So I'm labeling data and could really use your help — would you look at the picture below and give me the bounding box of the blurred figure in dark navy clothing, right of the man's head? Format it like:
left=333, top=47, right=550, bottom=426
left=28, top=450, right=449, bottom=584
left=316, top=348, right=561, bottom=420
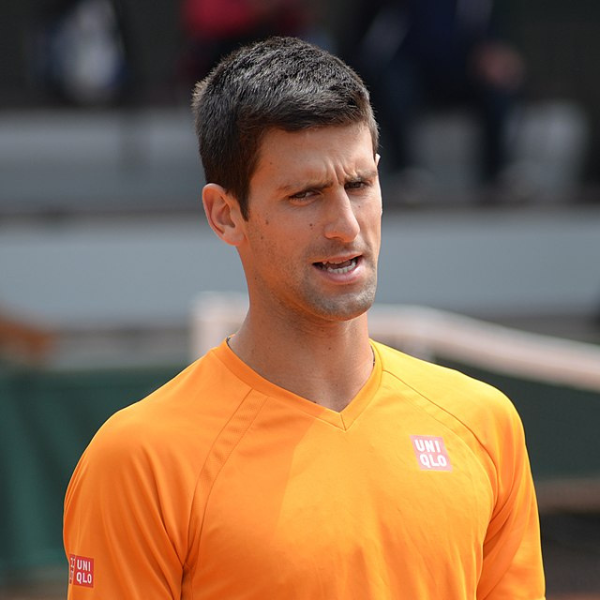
left=348, top=0, right=524, bottom=195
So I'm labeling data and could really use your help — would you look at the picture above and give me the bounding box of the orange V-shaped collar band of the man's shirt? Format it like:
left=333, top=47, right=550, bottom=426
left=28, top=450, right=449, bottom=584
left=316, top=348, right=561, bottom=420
left=212, top=340, right=382, bottom=431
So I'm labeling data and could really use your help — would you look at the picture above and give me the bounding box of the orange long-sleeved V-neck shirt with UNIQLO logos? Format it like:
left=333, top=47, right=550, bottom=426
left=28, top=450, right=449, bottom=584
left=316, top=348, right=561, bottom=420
left=64, top=343, right=544, bottom=600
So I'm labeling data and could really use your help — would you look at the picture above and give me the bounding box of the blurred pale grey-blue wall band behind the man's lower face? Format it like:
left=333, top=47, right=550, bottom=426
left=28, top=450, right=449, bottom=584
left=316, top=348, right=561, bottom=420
left=0, top=208, right=600, bottom=326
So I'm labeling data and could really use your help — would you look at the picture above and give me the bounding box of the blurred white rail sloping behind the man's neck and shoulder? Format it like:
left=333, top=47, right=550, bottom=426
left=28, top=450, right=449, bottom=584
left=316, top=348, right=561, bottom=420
left=192, top=293, right=600, bottom=391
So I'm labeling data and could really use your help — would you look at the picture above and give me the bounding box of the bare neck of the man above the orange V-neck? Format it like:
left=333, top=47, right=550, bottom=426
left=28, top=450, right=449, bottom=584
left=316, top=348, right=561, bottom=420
left=230, top=311, right=373, bottom=411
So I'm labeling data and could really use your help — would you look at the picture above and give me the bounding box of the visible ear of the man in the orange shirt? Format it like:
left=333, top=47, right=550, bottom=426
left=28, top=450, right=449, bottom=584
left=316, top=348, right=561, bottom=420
left=202, top=183, right=244, bottom=246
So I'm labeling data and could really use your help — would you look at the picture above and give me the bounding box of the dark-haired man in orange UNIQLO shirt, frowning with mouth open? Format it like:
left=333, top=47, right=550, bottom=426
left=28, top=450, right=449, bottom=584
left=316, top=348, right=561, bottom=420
left=65, top=38, right=544, bottom=600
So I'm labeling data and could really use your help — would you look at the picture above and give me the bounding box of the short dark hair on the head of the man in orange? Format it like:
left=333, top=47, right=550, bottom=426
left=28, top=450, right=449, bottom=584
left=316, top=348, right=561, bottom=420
left=192, top=37, right=379, bottom=218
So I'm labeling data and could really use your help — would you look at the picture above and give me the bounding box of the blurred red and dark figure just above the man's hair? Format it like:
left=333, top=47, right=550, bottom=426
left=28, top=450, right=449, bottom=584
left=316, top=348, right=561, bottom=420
left=181, top=0, right=313, bottom=83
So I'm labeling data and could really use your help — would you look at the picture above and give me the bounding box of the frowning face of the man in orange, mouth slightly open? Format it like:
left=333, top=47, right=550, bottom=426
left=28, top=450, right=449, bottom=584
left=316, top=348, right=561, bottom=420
left=238, top=124, right=382, bottom=322
